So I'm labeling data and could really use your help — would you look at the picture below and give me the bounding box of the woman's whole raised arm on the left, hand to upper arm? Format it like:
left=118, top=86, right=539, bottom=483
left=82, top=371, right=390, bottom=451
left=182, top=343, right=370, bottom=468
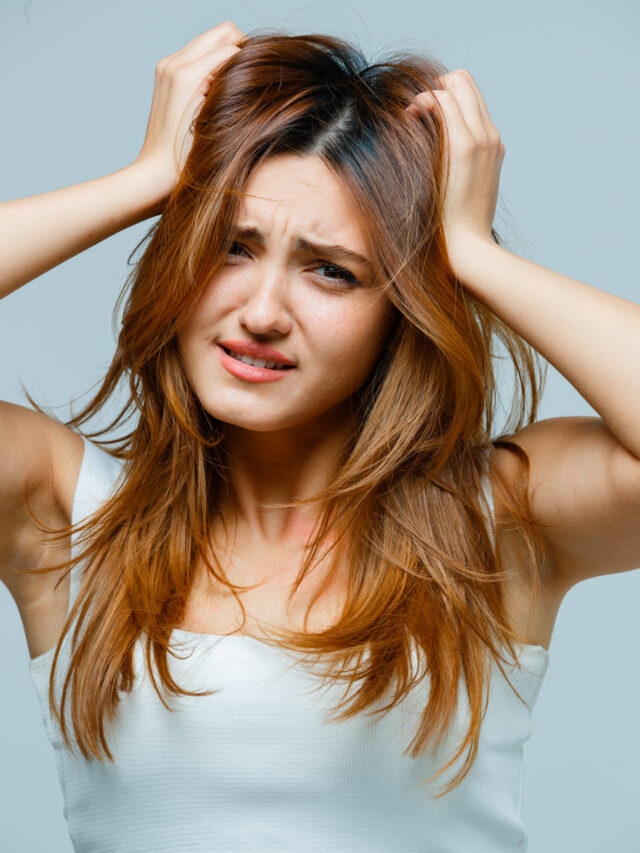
left=0, top=22, right=244, bottom=615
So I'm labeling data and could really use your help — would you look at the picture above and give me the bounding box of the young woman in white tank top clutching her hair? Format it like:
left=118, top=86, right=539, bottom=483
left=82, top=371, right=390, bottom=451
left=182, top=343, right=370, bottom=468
left=0, top=22, right=640, bottom=853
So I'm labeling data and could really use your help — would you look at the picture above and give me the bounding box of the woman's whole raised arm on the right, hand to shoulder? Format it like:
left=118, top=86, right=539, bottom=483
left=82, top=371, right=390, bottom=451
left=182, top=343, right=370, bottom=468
left=409, top=69, right=640, bottom=591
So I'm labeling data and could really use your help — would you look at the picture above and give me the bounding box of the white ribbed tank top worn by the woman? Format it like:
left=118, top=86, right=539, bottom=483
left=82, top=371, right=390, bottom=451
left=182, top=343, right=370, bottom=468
left=29, top=439, right=549, bottom=853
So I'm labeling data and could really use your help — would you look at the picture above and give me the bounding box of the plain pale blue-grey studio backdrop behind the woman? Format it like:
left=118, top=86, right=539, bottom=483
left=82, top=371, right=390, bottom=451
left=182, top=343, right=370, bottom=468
left=0, top=0, right=640, bottom=853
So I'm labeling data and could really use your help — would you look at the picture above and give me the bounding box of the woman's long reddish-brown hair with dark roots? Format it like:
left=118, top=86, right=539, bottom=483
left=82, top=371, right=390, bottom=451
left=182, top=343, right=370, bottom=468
left=22, top=32, right=544, bottom=796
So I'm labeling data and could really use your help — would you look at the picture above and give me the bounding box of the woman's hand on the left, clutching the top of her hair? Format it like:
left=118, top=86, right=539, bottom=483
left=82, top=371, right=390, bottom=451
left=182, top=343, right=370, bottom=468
left=132, top=21, right=246, bottom=209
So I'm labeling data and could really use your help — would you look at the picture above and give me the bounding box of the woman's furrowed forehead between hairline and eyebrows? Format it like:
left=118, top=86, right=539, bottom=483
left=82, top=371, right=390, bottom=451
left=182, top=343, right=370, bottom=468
left=238, top=154, right=367, bottom=254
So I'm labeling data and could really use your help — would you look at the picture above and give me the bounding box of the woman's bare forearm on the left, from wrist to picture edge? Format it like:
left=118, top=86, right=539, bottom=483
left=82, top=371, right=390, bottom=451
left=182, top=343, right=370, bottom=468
left=0, top=164, right=168, bottom=299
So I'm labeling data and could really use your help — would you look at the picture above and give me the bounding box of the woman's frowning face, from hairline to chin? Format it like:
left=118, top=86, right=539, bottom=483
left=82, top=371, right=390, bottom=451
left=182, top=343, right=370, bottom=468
left=178, top=154, right=395, bottom=432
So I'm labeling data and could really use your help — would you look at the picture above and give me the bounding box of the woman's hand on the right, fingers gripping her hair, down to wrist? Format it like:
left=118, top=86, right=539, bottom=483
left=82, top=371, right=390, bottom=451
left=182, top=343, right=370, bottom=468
left=407, top=68, right=505, bottom=261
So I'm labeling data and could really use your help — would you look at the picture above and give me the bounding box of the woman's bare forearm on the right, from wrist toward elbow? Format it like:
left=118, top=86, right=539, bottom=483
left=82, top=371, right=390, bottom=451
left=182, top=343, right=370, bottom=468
left=450, top=237, right=640, bottom=457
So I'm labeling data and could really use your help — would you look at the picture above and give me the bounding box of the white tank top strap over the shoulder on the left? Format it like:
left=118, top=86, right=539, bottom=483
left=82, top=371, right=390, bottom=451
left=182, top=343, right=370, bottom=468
left=67, top=435, right=123, bottom=613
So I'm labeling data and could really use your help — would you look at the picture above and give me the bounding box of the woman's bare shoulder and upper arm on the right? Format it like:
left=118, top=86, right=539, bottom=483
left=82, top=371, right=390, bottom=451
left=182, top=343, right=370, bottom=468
left=484, top=416, right=640, bottom=591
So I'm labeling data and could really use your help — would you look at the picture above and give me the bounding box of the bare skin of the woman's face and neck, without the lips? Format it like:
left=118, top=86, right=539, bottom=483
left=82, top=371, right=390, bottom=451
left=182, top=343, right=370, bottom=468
left=178, top=154, right=395, bottom=550
